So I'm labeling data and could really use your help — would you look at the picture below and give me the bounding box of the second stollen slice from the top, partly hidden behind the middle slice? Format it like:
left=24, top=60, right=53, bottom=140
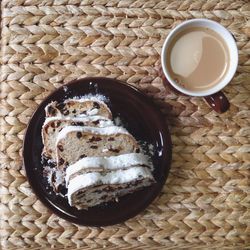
left=42, top=116, right=113, bottom=160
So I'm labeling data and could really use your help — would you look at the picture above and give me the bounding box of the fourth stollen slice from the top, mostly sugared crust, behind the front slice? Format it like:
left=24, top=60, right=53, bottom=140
left=65, top=153, right=153, bottom=185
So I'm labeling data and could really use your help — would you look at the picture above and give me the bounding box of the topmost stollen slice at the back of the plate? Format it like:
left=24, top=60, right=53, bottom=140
left=45, top=99, right=112, bottom=119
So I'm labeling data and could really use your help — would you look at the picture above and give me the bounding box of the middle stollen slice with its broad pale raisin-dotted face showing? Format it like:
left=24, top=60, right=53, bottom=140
left=56, top=126, right=140, bottom=168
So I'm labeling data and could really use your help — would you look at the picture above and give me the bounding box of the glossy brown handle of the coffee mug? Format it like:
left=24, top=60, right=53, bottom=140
left=204, top=91, right=230, bottom=113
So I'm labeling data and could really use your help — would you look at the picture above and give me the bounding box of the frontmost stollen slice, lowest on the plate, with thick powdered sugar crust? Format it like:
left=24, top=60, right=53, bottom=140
left=68, top=166, right=155, bottom=209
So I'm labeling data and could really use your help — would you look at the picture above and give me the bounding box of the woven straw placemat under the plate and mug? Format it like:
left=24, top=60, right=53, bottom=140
left=0, top=0, right=250, bottom=249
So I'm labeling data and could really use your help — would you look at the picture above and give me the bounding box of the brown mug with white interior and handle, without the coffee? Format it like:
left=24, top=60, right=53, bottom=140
left=161, top=19, right=238, bottom=113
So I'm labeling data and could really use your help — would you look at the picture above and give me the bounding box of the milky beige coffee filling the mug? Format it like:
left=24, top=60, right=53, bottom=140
left=166, top=27, right=229, bottom=91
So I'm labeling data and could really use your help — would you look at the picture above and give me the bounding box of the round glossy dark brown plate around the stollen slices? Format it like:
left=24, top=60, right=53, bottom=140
left=23, top=78, right=171, bottom=226
